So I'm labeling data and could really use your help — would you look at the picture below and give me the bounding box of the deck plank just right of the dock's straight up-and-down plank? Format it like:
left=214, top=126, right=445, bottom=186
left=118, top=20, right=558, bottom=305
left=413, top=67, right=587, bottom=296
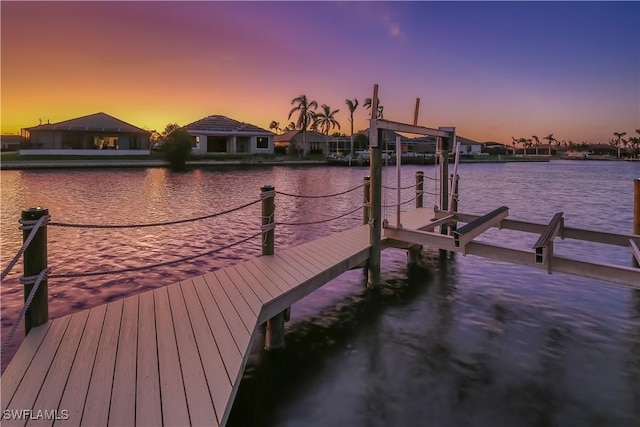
left=153, top=284, right=190, bottom=426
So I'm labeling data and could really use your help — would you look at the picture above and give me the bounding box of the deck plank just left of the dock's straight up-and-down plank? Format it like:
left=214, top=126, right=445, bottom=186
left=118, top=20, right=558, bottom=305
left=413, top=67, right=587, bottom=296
left=109, top=295, right=139, bottom=426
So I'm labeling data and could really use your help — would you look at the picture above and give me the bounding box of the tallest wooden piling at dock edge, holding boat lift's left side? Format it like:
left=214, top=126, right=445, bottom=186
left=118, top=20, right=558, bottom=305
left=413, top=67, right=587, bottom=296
left=367, top=84, right=384, bottom=288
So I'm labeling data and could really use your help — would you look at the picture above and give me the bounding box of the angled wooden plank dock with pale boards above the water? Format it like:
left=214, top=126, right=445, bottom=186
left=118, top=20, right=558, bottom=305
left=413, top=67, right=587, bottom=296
left=2, top=209, right=433, bottom=426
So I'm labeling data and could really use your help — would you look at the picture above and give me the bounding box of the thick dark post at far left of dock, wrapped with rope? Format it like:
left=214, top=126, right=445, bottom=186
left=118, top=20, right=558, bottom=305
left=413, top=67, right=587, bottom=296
left=20, top=207, right=49, bottom=335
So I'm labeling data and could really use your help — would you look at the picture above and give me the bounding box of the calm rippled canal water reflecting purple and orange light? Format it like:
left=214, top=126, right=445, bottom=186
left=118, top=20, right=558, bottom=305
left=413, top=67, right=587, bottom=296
left=0, top=161, right=640, bottom=426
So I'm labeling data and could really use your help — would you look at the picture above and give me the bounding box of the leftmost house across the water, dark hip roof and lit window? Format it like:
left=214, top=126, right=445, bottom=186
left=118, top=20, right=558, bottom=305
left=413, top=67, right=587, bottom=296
left=20, top=113, right=151, bottom=156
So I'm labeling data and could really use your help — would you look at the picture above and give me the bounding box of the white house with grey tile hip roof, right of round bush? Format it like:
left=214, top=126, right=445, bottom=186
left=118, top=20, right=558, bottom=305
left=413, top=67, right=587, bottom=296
left=182, top=115, right=275, bottom=154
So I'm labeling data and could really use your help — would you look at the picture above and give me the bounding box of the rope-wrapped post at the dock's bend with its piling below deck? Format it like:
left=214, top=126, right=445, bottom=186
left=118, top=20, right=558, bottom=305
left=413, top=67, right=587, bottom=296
left=260, top=185, right=290, bottom=350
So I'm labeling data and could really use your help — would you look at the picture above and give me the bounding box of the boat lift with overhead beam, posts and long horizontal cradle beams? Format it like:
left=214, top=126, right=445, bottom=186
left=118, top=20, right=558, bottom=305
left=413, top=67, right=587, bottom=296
left=369, top=85, right=640, bottom=290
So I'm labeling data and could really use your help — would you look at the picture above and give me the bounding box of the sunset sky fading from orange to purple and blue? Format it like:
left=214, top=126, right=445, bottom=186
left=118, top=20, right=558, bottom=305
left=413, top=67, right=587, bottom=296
left=0, top=1, right=640, bottom=142
